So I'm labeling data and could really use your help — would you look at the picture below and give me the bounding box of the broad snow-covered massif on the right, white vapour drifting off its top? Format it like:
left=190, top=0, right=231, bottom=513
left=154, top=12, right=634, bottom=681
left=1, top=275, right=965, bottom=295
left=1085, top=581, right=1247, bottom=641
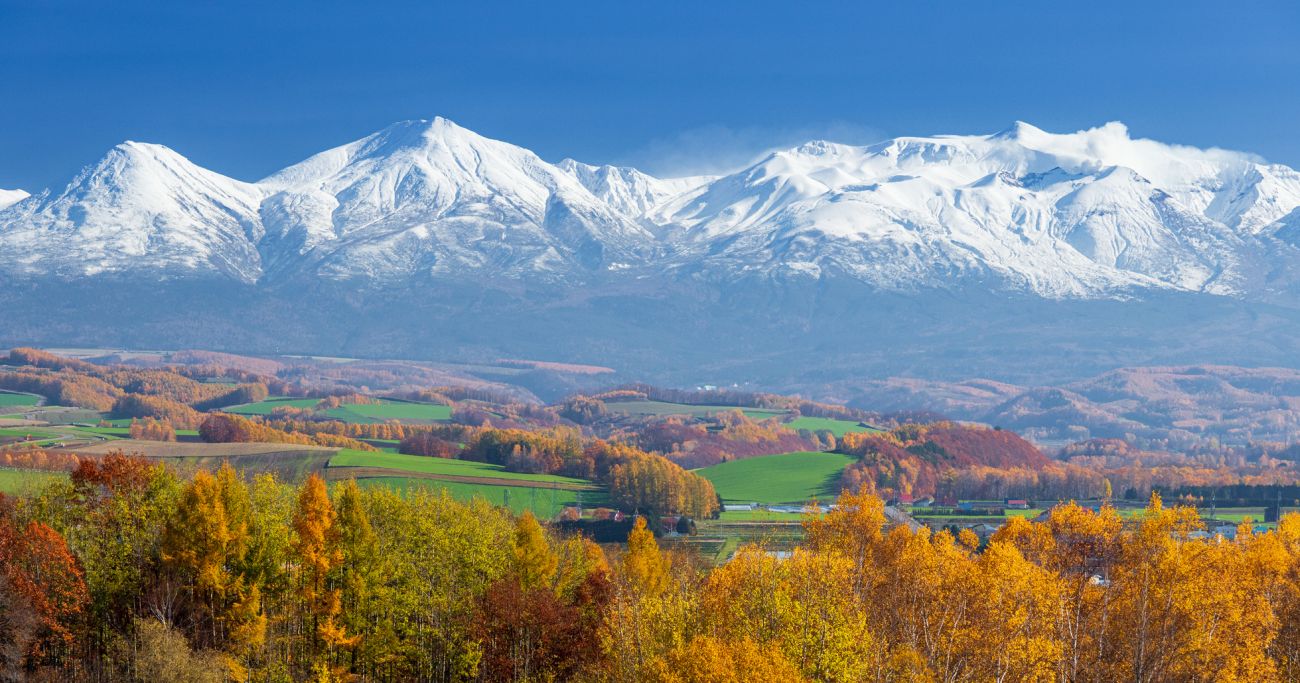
left=657, top=124, right=1300, bottom=298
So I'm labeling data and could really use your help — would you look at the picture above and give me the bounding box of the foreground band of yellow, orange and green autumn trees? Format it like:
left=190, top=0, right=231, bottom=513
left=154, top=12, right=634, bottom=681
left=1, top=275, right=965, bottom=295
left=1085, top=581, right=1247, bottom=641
left=0, top=455, right=1300, bottom=683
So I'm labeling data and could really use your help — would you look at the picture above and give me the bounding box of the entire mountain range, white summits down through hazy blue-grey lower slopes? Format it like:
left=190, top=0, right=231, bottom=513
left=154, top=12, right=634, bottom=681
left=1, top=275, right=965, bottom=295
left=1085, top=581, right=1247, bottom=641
left=0, top=118, right=1300, bottom=384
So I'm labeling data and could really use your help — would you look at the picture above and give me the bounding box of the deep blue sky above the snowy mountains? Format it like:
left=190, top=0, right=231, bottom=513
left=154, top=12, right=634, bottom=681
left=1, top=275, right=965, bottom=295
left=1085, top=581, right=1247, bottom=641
left=0, top=0, right=1300, bottom=190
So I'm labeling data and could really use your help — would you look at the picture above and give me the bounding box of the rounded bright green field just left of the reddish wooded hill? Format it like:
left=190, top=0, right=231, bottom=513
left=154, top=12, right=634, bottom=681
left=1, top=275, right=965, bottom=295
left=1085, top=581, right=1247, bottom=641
left=696, top=451, right=854, bottom=503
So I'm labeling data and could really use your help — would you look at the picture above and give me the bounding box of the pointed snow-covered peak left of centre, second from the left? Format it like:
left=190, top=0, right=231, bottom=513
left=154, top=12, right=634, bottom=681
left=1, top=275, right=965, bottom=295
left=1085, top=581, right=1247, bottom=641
left=260, top=118, right=654, bottom=282
